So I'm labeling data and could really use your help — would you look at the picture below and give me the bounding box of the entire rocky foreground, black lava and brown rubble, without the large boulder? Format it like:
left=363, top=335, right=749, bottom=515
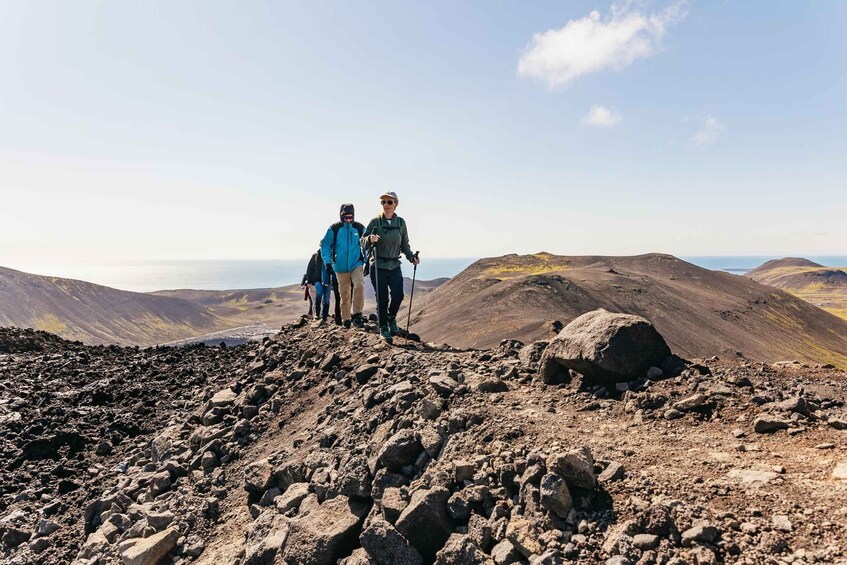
left=0, top=323, right=847, bottom=565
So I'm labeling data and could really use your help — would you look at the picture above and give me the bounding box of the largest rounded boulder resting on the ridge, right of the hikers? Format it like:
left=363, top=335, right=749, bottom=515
left=540, top=308, right=671, bottom=384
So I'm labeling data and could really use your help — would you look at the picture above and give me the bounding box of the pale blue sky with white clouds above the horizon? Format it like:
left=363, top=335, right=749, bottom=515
left=0, top=0, right=847, bottom=267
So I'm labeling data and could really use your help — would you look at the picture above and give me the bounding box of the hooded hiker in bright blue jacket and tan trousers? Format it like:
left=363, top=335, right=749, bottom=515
left=321, top=204, right=365, bottom=328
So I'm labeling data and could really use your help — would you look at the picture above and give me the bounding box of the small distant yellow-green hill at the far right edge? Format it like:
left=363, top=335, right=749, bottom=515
left=745, top=257, right=847, bottom=320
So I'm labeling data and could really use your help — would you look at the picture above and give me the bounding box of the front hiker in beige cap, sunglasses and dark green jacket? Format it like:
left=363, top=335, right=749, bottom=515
left=362, top=192, right=420, bottom=343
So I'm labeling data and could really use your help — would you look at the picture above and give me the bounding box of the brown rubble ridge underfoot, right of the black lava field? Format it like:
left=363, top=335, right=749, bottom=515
left=0, top=318, right=847, bottom=565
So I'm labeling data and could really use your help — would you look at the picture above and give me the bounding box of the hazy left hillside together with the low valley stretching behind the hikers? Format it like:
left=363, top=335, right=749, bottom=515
left=0, top=267, right=447, bottom=346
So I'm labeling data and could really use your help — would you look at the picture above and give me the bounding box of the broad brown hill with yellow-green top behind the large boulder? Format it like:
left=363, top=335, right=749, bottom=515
left=412, top=253, right=847, bottom=367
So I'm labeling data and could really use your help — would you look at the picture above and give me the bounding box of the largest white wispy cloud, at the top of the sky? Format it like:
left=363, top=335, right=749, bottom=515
left=518, top=0, right=686, bottom=88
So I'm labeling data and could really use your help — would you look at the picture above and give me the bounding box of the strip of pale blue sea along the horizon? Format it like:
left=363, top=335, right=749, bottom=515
left=3, top=255, right=847, bottom=292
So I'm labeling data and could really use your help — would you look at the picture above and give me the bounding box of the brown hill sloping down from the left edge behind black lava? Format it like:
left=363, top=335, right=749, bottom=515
left=0, top=267, right=226, bottom=346
